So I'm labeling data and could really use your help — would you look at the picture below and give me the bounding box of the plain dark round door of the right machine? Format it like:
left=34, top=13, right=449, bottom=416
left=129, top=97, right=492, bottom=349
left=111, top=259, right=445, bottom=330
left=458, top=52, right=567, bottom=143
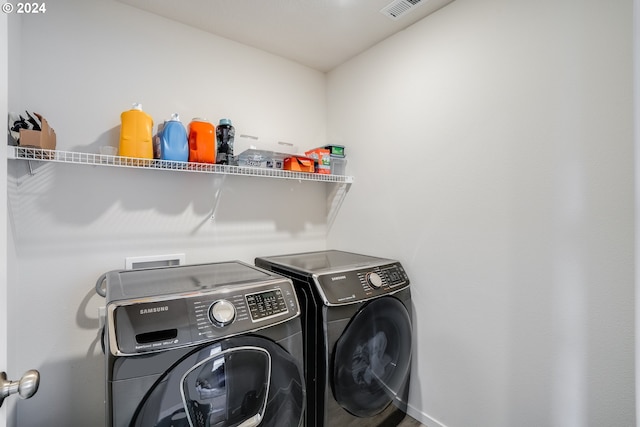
left=332, top=297, right=411, bottom=418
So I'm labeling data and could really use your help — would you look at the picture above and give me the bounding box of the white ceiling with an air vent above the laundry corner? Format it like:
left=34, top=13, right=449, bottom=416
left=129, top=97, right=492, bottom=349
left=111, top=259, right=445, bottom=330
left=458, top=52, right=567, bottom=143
left=119, top=0, right=453, bottom=72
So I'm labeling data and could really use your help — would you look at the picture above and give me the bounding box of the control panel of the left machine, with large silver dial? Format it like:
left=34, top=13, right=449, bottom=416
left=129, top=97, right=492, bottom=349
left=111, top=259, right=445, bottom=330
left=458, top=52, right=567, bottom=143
left=107, top=278, right=300, bottom=356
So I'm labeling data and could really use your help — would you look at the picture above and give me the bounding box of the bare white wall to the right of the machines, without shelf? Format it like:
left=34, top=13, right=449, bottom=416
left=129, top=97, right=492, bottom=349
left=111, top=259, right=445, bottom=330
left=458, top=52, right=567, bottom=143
left=327, top=0, right=635, bottom=427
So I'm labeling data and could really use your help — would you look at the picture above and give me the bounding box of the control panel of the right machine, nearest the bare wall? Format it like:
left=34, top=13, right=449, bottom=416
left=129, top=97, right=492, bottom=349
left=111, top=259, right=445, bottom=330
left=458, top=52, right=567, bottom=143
left=314, top=262, right=409, bottom=305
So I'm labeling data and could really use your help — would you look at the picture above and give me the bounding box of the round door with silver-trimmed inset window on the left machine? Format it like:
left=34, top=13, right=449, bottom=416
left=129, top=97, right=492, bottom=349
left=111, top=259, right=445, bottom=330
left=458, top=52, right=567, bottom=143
left=131, top=336, right=304, bottom=427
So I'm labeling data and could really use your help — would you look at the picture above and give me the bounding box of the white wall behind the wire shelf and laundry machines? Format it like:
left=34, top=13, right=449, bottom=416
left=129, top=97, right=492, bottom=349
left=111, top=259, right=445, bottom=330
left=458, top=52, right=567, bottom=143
left=8, top=0, right=327, bottom=426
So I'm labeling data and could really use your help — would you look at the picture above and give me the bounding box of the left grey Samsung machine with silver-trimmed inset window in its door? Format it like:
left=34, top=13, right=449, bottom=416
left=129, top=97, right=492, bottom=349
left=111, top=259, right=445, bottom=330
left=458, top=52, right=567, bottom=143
left=105, top=261, right=305, bottom=427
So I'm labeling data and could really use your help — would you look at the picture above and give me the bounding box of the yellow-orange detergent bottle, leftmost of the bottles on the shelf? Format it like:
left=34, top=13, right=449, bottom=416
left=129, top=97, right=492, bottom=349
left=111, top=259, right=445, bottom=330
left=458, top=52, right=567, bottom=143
left=119, top=104, right=153, bottom=159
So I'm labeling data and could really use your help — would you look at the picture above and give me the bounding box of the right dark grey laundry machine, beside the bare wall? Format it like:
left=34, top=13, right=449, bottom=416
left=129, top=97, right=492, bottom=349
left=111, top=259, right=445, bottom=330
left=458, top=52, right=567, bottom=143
left=255, top=250, right=412, bottom=427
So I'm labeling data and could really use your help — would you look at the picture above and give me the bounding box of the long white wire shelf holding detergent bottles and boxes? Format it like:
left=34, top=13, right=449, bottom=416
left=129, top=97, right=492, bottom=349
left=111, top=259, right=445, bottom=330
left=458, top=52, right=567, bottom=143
left=7, top=146, right=353, bottom=184
